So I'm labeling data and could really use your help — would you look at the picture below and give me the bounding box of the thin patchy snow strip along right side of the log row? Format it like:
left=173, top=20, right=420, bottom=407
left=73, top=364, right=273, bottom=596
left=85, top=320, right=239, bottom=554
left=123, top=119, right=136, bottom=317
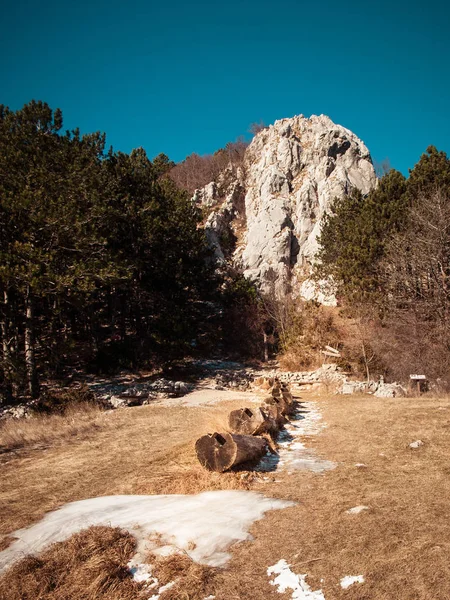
left=257, top=402, right=336, bottom=473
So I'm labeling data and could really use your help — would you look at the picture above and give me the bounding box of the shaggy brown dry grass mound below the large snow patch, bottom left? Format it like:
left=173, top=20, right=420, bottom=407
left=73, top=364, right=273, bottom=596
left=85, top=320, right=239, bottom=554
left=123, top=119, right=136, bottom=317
left=0, top=527, right=142, bottom=600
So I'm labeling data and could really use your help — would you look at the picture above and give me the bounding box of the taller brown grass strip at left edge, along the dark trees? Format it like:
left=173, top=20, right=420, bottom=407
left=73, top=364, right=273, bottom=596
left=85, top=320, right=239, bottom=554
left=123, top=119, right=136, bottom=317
left=0, top=403, right=101, bottom=453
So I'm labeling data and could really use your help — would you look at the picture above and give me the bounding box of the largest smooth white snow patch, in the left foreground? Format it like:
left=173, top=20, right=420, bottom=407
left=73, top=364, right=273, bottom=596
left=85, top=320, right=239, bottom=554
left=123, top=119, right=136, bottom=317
left=0, top=490, right=294, bottom=577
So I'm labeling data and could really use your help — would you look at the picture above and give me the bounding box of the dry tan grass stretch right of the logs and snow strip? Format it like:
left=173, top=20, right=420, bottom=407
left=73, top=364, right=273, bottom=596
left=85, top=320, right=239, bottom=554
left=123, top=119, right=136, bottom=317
left=213, top=396, right=450, bottom=600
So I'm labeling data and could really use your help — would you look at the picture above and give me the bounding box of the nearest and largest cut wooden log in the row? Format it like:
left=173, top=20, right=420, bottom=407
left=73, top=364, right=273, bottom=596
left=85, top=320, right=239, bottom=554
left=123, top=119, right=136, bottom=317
left=195, top=432, right=267, bottom=473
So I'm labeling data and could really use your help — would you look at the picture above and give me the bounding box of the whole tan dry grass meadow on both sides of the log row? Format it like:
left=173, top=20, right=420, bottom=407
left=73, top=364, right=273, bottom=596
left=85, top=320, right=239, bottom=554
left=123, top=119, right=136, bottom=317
left=0, top=386, right=450, bottom=600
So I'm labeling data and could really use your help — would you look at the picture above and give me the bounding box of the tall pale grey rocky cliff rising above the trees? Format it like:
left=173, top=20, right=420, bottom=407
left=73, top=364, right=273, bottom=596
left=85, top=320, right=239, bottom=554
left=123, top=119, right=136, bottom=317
left=194, top=115, right=377, bottom=300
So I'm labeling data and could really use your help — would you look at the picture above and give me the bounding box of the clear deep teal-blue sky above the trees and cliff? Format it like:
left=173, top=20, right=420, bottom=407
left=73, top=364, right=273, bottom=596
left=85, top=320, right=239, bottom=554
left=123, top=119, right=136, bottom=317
left=0, top=0, right=450, bottom=173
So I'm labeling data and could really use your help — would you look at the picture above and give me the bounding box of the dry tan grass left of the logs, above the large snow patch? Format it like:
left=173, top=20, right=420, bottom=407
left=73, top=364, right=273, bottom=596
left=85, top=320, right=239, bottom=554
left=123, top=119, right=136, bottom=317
left=0, top=394, right=249, bottom=543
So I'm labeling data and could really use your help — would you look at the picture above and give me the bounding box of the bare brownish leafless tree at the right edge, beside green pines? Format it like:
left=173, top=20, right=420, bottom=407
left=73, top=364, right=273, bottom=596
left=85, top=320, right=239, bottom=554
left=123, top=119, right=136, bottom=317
left=379, top=189, right=450, bottom=383
